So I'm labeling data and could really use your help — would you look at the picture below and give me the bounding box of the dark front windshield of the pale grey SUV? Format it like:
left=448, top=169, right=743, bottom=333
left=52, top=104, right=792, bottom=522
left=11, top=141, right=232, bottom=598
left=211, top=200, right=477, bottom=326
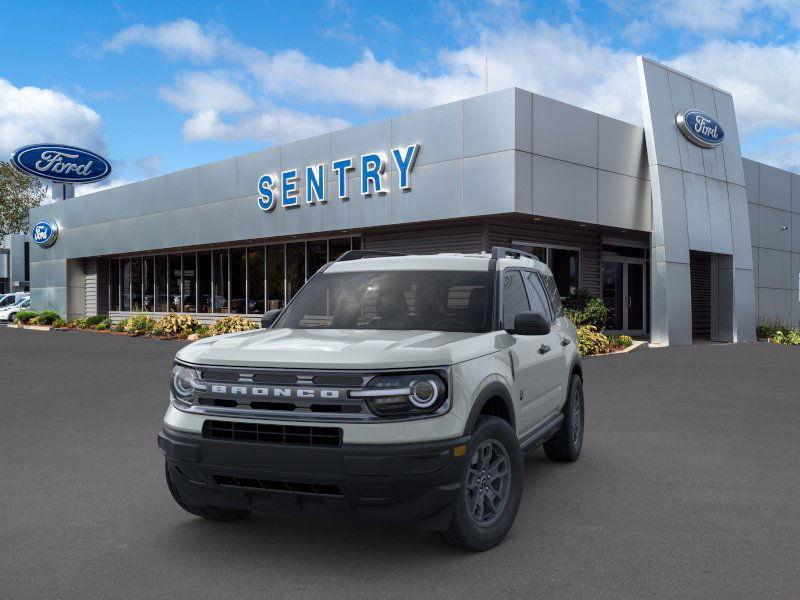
left=274, top=271, right=493, bottom=333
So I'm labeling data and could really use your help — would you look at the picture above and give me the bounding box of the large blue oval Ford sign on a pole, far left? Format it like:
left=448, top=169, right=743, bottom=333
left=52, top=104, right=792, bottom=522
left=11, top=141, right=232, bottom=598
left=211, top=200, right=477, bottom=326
left=11, top=144, right=111, bottom=183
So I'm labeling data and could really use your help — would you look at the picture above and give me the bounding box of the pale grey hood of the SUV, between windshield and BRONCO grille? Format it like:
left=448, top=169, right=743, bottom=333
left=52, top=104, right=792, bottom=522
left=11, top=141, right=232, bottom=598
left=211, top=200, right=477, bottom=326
left=177, top=329, right=499, bottom=370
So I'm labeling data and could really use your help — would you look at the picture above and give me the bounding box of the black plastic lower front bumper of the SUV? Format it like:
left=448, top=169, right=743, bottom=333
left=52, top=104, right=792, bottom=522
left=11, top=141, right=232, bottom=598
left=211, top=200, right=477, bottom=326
left=158, top=427, right=469, bottom=529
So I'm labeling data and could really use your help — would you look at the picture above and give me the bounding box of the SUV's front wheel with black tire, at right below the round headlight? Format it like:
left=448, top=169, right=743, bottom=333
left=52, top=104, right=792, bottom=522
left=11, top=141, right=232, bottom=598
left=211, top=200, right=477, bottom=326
left=437, top=416, right=523, bottom=551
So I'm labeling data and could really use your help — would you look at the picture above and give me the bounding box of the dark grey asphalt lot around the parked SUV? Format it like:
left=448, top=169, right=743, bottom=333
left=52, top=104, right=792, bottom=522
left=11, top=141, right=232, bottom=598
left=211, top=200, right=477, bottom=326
left=0, top=327, right=800, bottom=599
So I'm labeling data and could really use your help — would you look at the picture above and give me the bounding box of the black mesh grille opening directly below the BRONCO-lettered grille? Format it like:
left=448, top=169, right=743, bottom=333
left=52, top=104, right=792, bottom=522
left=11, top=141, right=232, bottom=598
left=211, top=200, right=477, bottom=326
left=203, top=421, right=342, bottom=446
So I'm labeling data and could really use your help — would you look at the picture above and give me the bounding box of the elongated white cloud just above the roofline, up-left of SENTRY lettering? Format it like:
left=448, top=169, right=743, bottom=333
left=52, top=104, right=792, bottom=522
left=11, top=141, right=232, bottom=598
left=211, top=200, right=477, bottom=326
left=183, top=108, right=349, bottom=143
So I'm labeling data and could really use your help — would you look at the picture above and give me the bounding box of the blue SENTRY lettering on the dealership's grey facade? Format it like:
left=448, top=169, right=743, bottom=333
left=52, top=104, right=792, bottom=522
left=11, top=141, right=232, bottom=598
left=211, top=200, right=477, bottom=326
left=258, top=144, right=419, bottom=212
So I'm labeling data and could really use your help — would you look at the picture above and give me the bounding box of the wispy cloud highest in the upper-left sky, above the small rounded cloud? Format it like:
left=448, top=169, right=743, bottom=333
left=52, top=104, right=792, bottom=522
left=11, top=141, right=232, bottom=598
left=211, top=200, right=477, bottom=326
left=102, top=19, right=220, bottom=61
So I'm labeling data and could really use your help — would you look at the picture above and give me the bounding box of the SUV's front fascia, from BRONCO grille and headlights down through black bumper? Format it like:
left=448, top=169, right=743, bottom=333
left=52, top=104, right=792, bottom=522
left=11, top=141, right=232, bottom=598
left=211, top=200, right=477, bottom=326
left=159, top=354, right=478, bottom=529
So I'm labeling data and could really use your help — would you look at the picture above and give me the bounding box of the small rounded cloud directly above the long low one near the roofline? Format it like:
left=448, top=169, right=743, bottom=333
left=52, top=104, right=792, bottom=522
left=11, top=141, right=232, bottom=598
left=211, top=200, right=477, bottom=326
left=161, top=71, right=255, bottom=112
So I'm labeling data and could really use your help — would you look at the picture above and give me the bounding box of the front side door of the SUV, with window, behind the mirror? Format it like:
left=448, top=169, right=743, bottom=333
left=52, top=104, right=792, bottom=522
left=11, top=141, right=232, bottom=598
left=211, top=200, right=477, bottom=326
left=501, top=269, right=563, bottom=435
